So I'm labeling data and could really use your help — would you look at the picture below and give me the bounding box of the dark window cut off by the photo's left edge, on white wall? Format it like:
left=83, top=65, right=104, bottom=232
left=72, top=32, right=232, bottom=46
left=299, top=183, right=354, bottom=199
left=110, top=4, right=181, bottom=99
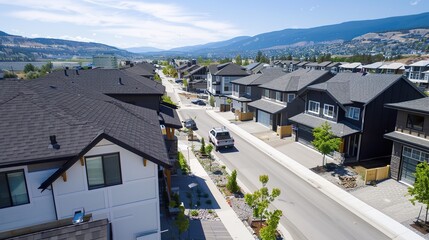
left=0, top=170, right=30, bottom=208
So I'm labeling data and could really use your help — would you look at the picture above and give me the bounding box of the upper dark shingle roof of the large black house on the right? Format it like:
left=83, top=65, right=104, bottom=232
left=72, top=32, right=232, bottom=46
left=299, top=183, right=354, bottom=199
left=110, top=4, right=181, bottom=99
left=308, top=73, right=402, bottom=105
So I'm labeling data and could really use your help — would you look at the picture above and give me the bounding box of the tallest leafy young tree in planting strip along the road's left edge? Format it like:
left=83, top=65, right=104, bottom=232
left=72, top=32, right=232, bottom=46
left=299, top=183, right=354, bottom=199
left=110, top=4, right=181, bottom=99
left=244, top=175, right=281, bottom=230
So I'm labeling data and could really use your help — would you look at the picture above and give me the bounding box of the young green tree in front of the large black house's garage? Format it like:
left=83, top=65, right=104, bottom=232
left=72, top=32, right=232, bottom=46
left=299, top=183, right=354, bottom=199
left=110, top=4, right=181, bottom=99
left=311, top=122, right=341, bottom=166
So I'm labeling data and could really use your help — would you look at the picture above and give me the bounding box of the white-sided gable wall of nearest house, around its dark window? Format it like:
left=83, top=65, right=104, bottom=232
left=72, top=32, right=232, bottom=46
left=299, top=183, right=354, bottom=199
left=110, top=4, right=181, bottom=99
left=53, top=140, right=160, bottom=239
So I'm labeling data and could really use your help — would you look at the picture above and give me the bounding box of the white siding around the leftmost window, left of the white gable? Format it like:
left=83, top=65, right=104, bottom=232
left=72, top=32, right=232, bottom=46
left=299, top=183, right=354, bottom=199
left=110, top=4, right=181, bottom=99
left=0, top=166, right=56, bottom=231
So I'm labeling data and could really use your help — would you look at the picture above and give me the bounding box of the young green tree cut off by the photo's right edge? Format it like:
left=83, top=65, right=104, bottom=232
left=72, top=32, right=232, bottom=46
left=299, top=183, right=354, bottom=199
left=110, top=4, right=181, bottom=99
left=408, top=162, right=429, bottom=223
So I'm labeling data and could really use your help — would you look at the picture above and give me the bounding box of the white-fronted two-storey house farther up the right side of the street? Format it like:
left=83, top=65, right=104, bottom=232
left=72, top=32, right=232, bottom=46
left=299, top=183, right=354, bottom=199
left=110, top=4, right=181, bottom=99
left=207, top=62, right=249, bottom=106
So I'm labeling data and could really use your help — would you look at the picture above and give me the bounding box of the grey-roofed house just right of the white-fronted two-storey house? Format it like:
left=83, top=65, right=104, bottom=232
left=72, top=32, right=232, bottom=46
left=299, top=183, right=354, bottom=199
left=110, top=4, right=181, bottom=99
left=227, top=68, right=286, bottom=116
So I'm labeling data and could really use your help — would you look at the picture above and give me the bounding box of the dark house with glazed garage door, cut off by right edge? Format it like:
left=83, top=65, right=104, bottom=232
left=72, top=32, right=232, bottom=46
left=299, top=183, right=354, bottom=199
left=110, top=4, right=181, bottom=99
left=384, top=97, right=429, bottom=185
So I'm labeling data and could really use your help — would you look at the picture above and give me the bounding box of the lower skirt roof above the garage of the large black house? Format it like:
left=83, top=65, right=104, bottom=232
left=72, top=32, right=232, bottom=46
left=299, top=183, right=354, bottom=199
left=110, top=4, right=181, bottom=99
left=289, top=113, right=359, bottom=137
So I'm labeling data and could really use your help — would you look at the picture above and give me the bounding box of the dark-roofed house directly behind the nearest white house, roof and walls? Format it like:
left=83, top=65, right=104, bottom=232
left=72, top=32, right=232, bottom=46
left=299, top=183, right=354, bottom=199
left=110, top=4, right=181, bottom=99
left=34, top=67, right=182, bottom=159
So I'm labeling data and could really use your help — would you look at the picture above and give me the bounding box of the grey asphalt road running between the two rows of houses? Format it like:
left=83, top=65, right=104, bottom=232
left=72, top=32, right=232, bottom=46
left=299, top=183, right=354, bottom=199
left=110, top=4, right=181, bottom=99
left=179, top=107, right=389, bottom=239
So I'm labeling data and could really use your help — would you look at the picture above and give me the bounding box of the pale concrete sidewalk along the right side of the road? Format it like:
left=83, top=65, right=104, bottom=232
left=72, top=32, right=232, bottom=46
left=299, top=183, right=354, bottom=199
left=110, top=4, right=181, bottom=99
left=207, top=110, right=422, bottom=240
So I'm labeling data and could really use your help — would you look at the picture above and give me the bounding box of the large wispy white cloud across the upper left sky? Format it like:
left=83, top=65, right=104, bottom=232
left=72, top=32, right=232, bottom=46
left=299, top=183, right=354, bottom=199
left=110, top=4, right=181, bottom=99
left=0, top=0, right=241, bottom=49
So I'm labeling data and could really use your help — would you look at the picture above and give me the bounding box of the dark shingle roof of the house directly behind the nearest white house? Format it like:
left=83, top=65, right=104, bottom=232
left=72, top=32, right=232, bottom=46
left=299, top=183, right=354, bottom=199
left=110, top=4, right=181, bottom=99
left=34, top=69, right=165, bottom=95
